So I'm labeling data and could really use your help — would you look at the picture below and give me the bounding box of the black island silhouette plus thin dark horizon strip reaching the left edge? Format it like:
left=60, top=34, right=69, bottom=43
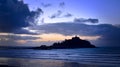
left=0, top=36, right=96, bottom=50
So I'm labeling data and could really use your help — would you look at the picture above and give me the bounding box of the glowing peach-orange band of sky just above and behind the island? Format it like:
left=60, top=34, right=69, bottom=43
left=0, top=33, right=101, bottom=45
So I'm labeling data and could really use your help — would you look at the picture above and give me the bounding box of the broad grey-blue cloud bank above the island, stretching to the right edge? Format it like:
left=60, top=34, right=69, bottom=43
left=31, top=23, right=120, bottom=46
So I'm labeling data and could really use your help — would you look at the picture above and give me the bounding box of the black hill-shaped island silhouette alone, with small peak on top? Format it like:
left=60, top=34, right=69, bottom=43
left=33, top=36, right=96, bottom=49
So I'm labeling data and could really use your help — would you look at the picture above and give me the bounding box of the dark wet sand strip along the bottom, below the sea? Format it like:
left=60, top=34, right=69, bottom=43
left=0, top=58, right=114, bottom=67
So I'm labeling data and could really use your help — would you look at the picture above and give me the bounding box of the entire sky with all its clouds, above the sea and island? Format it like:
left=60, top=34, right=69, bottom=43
left=0, top=0, right=120, bottom=47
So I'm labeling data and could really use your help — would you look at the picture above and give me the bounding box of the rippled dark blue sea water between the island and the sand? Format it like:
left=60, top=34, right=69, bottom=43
left=0, top=48, right=120, bottom=67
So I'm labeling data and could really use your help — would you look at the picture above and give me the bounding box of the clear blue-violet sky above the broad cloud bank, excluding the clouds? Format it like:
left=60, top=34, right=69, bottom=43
left=24, top=0, right=120, bottom=24
